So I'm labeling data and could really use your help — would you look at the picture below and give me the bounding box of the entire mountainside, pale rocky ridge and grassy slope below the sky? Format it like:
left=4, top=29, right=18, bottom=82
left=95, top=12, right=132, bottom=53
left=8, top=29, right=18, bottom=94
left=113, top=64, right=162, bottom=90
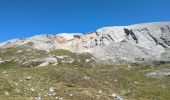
left=0, top=22, right=170, bottom=100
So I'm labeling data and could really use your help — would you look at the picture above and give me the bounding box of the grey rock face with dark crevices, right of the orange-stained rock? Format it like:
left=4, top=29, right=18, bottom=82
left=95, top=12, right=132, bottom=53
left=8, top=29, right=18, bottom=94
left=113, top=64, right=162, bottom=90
left=93, top=22, right=170, bottom=61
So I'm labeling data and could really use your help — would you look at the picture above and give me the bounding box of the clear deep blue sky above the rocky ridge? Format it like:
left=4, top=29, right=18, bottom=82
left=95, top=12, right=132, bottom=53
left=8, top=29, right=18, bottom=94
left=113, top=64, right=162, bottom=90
left=0, top=0, right=170, bottom=42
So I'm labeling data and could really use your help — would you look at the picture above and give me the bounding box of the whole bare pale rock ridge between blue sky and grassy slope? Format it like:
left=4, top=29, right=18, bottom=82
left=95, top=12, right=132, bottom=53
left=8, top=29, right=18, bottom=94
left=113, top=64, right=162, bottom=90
left=0, top=22, right=170, bottom=62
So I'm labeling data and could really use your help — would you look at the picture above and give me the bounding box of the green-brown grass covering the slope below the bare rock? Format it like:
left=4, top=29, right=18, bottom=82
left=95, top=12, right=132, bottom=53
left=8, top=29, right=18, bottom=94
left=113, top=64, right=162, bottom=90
left=0, top=47, right=170, bottom=100
